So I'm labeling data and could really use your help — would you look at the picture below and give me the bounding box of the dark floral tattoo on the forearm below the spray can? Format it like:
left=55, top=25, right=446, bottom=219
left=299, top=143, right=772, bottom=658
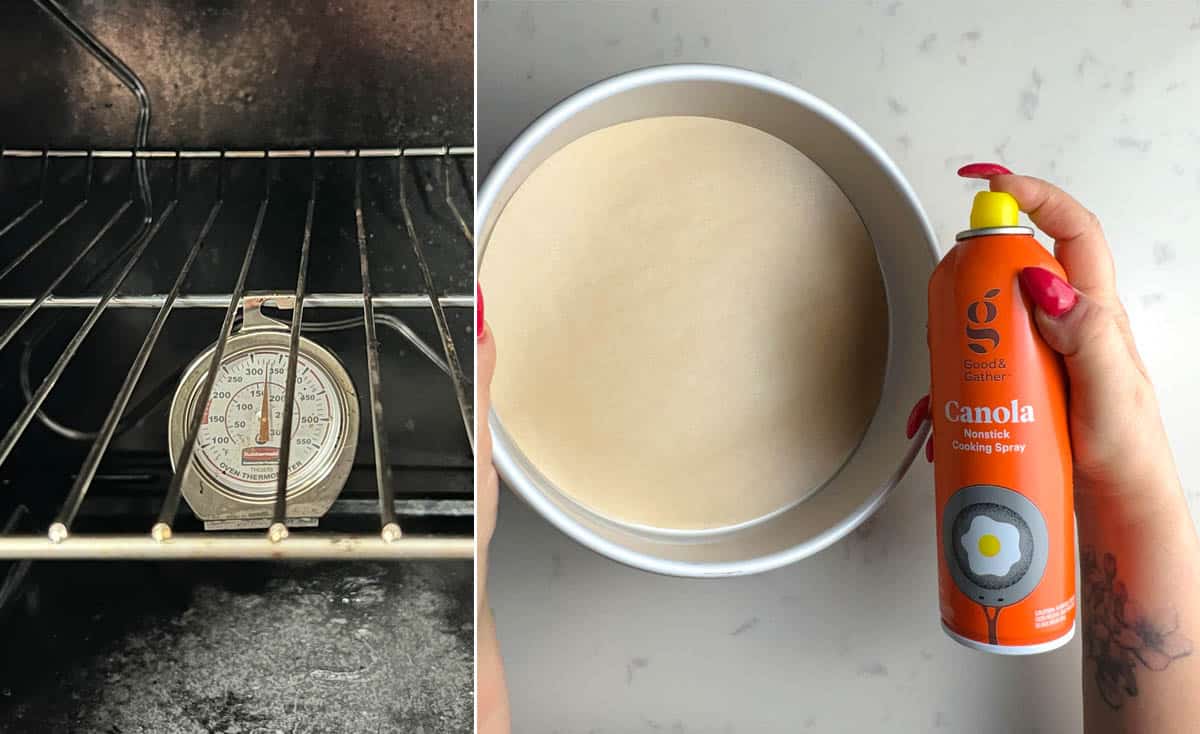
left=1080, top=547, right=1192, bottom=709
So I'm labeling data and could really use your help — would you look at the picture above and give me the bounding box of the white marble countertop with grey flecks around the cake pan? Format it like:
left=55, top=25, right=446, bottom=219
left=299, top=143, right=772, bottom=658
left=478, top=0, right=1200, bottom=734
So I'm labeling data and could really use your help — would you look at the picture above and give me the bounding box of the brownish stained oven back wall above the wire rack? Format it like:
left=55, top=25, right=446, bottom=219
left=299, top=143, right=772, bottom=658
left=0, top=0, right=474, bottom=148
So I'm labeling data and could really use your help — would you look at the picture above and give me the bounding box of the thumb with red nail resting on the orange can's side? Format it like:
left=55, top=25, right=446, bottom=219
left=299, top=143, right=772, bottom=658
left=1020, top=267, right=1136, bottom=402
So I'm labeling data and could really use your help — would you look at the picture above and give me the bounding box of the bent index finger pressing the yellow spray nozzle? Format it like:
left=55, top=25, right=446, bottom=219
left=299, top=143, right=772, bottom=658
left=989, top=175, right=1117, bottom=303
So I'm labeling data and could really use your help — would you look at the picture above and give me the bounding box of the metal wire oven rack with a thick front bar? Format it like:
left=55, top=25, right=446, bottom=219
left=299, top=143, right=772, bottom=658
left=0, top=145, right=474, bottom=560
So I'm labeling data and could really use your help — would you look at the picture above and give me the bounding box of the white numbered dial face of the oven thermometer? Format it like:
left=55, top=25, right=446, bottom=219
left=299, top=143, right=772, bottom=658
left=193, top=347, right=346, bottom=498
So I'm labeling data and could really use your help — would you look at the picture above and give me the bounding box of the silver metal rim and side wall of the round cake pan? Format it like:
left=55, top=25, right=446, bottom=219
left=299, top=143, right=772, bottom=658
left=475, top=65, right=938, bottom=577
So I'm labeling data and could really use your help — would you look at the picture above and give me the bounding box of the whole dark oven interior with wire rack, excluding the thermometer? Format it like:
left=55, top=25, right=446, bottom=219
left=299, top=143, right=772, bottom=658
left=0, top=0, right=474, bottom=732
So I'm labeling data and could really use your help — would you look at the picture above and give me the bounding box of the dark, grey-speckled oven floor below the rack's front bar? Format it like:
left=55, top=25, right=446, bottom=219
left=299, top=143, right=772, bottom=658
left=0, top=561, right=473, bottom=734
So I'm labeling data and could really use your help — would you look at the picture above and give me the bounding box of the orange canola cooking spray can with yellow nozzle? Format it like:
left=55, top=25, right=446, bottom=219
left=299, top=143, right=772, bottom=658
left=929, top=191, right=1075, bottom=655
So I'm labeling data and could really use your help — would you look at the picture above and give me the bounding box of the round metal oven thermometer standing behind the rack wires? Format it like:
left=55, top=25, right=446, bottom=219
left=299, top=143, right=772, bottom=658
left=169, top=296, right=359, bottom=530
